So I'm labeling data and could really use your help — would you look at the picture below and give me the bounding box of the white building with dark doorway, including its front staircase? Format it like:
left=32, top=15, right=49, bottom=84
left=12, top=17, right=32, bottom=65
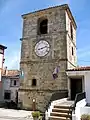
left=46, top=66, right=90, bottom=120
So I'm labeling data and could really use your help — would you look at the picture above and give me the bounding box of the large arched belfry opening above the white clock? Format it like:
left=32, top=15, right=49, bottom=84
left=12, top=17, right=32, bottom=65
left=38, top=18, right=48, bottom=34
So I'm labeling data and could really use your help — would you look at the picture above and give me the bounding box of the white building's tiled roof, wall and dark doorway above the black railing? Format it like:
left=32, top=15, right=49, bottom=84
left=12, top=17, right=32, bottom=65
left=67, top=66, right=90, bottom=104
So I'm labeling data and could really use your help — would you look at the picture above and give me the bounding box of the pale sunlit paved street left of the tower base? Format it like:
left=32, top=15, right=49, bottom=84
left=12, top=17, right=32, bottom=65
left=0, top=108, right=32, bottom=120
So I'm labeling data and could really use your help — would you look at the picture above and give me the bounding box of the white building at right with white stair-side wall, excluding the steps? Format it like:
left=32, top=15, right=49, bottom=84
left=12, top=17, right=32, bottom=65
left=67, top=66, right=90, bottom=120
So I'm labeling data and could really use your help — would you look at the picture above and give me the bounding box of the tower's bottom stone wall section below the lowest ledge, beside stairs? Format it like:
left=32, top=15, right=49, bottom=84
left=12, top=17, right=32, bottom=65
left=18, top=90, right=52, bottom=112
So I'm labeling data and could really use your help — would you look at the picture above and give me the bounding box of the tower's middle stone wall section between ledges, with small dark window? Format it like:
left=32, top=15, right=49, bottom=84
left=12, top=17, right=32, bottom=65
left=21, top=61, right=67, bottom=90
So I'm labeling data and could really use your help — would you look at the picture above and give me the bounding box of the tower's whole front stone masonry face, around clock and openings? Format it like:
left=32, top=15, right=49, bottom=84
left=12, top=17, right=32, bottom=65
left=19, top=4, right=76, bottom=111
